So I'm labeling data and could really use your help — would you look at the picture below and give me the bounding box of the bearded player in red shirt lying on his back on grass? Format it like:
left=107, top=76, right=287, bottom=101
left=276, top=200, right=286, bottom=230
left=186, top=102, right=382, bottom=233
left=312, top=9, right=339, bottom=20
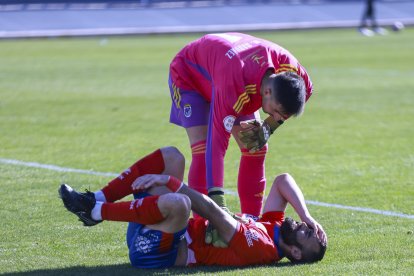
left=59, top=147, right=327, bottom=268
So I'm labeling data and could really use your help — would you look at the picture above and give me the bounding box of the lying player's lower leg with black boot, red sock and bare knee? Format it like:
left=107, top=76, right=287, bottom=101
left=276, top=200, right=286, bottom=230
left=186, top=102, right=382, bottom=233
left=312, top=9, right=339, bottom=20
left=59, top=181, right=191, bottom=233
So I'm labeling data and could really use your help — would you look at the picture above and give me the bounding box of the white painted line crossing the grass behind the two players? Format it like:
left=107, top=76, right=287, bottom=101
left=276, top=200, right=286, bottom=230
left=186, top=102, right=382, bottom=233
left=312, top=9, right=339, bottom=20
left=0, top=158, right=414, bottom=219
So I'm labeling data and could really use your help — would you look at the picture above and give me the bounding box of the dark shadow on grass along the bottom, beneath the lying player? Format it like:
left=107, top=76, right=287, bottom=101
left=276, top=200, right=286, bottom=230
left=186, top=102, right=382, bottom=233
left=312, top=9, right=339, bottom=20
left=3, top=262, right=293, bottom=276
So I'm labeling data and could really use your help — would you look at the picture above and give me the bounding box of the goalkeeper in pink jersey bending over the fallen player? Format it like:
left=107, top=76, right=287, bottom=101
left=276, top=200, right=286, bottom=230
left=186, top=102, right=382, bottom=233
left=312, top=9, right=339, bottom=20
left=169, top=33, right=312, bottom=216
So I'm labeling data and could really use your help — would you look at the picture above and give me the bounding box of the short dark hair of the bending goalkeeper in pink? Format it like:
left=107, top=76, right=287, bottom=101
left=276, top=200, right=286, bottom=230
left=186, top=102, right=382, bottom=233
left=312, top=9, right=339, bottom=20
left=272, top=72, right=306, bottom=116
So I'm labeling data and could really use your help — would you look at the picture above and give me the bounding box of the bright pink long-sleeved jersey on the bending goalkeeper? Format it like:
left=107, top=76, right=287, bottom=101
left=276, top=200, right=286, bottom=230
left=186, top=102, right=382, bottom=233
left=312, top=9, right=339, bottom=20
left=170, top=33, right=312, bottom=188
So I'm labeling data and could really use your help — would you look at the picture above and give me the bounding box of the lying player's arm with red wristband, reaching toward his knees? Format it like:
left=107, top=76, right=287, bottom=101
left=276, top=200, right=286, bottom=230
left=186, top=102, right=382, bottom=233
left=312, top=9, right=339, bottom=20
left=132, top=174, right=237, bottom=244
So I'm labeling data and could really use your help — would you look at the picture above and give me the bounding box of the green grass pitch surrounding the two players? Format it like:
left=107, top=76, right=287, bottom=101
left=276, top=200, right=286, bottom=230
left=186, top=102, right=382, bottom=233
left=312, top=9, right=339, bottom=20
left=0, top=29, right=414, bottom=275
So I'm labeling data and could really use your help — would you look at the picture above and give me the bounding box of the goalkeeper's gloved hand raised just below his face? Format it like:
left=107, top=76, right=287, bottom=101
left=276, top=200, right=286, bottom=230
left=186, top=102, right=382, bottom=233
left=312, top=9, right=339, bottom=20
left=238, top=119, right=272, bottom=152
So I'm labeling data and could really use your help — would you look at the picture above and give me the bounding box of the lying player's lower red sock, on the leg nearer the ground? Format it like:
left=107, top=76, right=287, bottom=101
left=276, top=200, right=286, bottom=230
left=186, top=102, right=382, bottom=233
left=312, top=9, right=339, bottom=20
left=101, top=196, right=165, bottom=225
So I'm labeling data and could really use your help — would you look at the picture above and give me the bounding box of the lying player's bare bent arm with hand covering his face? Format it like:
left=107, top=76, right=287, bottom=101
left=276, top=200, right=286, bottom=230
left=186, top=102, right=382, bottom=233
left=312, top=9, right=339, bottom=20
left=263, top=173, right=326, bottom=243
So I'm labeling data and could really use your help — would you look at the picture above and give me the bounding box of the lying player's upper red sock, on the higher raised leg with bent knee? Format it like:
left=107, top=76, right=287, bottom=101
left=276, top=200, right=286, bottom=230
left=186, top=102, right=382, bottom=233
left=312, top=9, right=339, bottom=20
left=102, top=149, right=165, bottom=202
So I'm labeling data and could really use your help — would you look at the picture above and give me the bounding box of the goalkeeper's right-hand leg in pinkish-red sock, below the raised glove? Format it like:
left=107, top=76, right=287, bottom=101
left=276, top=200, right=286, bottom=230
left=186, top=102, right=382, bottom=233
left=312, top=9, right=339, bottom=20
left=232, top=112, right=267, bottom=216
